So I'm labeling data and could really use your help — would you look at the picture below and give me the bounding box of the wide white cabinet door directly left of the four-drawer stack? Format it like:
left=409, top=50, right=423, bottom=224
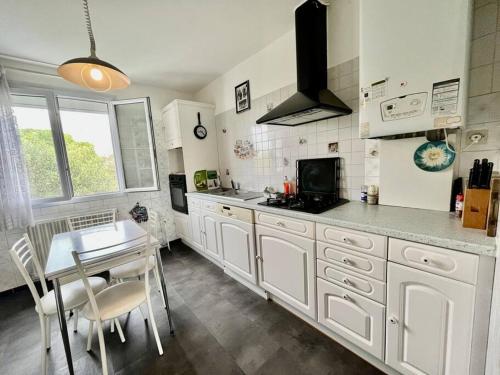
left=255, top=225, right=316, bottom=319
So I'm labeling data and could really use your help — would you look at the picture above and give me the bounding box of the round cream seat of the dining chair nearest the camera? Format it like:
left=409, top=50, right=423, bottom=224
left=82, top=281, right=146, bottom=320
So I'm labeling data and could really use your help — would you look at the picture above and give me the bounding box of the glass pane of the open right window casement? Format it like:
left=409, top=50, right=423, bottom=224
left=115, top=101, right=156, bottom=189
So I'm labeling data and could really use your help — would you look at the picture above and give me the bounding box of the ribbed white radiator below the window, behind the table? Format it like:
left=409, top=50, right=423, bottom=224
left=28, top=217, right=69, bottom=269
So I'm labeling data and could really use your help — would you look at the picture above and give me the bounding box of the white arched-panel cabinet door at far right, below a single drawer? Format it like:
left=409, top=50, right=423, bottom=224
left=386, top=263, right=474, bottom=375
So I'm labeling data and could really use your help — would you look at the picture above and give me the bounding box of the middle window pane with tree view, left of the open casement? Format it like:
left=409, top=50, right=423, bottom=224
left=57, top=98, right=118, bottom=197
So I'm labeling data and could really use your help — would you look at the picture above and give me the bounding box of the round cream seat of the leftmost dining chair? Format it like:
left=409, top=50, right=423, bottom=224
left=35, top=276, right=108, bottom=315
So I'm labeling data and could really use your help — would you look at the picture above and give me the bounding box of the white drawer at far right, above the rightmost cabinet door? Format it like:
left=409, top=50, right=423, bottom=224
left=389, top=238, right=479, bottom=284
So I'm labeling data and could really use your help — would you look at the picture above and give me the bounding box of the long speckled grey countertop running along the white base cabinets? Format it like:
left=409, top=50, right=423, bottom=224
left=186, top=193, right=497, bottom=256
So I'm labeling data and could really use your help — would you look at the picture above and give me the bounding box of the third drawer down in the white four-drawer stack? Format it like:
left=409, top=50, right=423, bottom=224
left=316, top=259, right=385, bottom=303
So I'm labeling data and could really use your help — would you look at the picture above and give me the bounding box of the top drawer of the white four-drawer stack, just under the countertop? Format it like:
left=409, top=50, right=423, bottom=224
left=316, top=224, right=387, bottom=258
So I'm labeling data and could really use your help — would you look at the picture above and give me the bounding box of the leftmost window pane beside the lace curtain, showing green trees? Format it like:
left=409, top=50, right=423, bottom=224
left=12, top=95, right=63, bottom=199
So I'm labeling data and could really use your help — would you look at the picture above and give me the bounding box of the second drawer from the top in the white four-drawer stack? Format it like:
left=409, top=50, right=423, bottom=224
left=317, top=241, right=387, bottom=281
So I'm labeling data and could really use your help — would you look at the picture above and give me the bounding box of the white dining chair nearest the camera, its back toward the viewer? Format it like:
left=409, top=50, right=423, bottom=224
left=72, top=233, right=163, bottom=375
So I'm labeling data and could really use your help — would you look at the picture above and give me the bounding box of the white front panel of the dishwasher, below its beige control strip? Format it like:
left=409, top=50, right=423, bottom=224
left=219, top=218, right=257, bottom=284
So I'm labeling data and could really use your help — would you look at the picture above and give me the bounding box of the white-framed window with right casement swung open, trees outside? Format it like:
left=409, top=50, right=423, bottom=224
left=12, top=89, right=158, bottom=205
